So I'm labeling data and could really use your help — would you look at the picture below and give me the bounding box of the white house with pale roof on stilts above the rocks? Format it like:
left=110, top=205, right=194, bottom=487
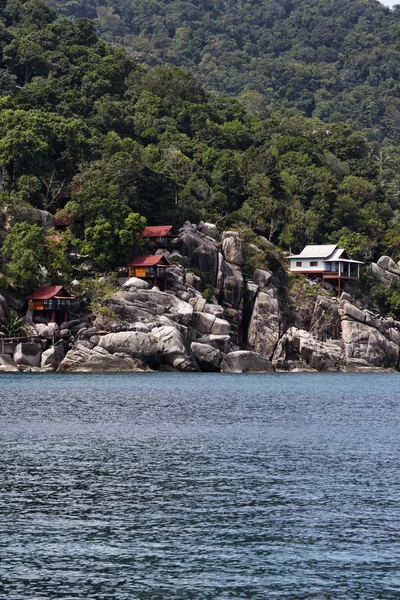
left=289, top=244, right=363, bottom=294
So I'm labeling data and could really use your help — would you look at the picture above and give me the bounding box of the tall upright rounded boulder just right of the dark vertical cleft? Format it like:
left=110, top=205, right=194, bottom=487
left=247, top=287, right=281, bottom=359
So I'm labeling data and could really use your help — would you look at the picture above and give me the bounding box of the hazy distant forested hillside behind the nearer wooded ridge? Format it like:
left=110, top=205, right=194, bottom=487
left=47, top=0, right=400, bottom=143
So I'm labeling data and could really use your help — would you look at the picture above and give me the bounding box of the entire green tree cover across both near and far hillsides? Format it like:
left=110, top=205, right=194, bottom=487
left=0, top=0, right=400, bottom=291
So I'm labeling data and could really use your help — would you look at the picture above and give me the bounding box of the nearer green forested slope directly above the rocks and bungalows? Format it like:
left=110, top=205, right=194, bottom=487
left=0, top=0, right=400, bottom=287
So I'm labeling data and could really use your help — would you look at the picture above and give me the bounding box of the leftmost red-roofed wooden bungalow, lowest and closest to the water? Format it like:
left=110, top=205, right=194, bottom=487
left=26, top=285, right=75, bottom=324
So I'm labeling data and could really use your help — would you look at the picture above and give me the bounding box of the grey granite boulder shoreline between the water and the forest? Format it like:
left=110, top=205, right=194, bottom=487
left=0, top=223, right=400, bottom=373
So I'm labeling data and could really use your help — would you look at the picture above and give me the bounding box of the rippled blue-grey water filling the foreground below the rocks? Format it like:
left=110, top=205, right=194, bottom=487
left=0, top=374, right=400, bottom=600
